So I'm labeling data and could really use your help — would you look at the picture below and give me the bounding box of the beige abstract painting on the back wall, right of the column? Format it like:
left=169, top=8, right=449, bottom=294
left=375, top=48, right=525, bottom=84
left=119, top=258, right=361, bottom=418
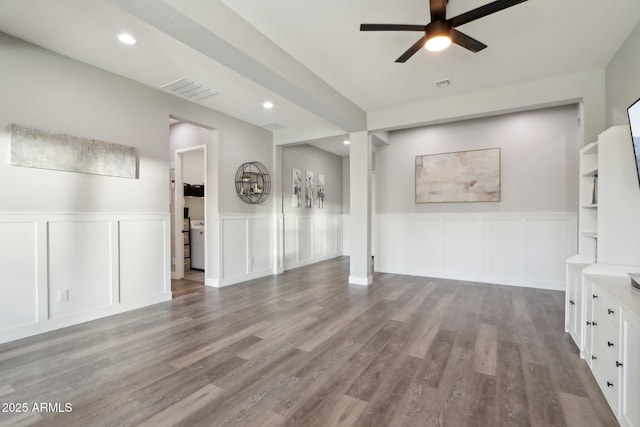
left=415, top=148, right=500, bottom=203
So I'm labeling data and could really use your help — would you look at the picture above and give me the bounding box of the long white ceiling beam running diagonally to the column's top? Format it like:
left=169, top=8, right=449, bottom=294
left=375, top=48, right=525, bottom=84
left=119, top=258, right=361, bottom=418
left=107, top=0, right=367, bottom=132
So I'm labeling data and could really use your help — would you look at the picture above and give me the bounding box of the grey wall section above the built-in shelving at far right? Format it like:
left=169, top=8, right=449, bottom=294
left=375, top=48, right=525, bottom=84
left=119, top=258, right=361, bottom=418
left=606, top=25, right=640, bottom=127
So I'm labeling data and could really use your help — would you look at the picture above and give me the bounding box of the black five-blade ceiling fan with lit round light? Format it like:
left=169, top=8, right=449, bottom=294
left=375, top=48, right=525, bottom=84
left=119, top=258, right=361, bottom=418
left=360, top=0, right=527, bottom=62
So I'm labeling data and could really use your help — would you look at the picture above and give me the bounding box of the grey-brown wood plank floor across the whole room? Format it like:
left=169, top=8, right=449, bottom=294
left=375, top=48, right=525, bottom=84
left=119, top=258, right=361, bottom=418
left=0, top=258, right=617, bottom=427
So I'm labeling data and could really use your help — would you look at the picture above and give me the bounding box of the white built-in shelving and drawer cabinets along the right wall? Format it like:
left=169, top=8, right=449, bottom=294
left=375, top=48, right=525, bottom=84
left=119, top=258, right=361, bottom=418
left=565, top=126, right=640, bottom=427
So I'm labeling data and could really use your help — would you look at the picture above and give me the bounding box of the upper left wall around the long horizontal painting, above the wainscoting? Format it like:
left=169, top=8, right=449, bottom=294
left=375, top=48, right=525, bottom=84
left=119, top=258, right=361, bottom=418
left=0, top=40, right=169, bottom=212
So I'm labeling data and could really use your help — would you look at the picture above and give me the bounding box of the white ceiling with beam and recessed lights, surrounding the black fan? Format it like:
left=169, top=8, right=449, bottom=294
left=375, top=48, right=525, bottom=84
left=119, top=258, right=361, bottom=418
left=0, top=0, right=640, bottom=154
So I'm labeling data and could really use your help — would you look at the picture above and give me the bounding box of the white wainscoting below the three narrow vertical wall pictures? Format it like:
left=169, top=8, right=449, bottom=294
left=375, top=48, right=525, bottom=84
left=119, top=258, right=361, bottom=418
left=284, top=214, right=348, bottom=270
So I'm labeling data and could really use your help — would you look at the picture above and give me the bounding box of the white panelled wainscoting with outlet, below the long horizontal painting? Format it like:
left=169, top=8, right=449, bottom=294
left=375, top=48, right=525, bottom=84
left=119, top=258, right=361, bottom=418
left=0, top=213, right=171, bottom=343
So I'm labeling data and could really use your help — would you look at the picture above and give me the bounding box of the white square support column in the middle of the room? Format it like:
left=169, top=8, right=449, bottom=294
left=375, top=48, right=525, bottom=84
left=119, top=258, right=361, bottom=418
left=349, top=131, right=373, bottom=286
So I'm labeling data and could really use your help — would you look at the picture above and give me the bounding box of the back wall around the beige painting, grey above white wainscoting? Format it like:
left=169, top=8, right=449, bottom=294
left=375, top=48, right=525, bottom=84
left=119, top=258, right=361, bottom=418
left=375, top=105, right=580, bottom=289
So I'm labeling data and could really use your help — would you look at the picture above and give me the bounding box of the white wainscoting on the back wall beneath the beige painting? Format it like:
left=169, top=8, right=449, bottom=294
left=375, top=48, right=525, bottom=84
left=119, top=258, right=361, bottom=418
left=374, top=212, right=577, bottom=290
